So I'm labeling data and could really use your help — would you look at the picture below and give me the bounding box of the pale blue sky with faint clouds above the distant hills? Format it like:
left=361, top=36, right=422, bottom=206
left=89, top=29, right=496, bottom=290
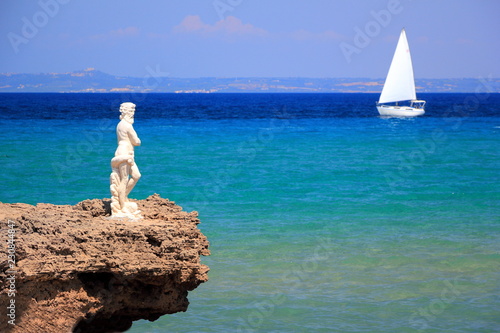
left=0, top=0, right=500, bottom=78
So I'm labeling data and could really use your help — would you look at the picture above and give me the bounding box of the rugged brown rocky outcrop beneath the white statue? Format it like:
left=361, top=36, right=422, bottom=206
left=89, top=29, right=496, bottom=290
left=0, top=194, right=210, bottom=333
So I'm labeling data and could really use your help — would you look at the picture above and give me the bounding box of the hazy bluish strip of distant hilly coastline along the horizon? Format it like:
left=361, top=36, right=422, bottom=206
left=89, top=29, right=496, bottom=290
left=0, top=68, right=500, bottom=93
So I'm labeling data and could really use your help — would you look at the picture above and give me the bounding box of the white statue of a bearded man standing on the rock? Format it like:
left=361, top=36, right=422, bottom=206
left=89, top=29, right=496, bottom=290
left=109, top=103, right=142, bottom=219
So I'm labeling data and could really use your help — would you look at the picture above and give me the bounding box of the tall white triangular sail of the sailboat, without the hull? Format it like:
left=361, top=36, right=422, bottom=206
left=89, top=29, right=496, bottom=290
left=378, top=29, right=417, bottom=103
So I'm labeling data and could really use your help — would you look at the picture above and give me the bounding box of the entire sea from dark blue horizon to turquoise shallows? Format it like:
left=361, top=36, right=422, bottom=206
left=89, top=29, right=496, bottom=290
left=0, top=91, right=500, bottom=333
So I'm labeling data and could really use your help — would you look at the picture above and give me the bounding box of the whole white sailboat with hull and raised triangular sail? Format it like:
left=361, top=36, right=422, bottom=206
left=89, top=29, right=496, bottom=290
left=377, top=29, right=425, bottom=117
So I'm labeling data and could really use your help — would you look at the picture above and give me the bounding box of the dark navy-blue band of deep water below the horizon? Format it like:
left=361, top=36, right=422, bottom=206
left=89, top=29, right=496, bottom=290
left=0, top=93, right=500, bottom=121
